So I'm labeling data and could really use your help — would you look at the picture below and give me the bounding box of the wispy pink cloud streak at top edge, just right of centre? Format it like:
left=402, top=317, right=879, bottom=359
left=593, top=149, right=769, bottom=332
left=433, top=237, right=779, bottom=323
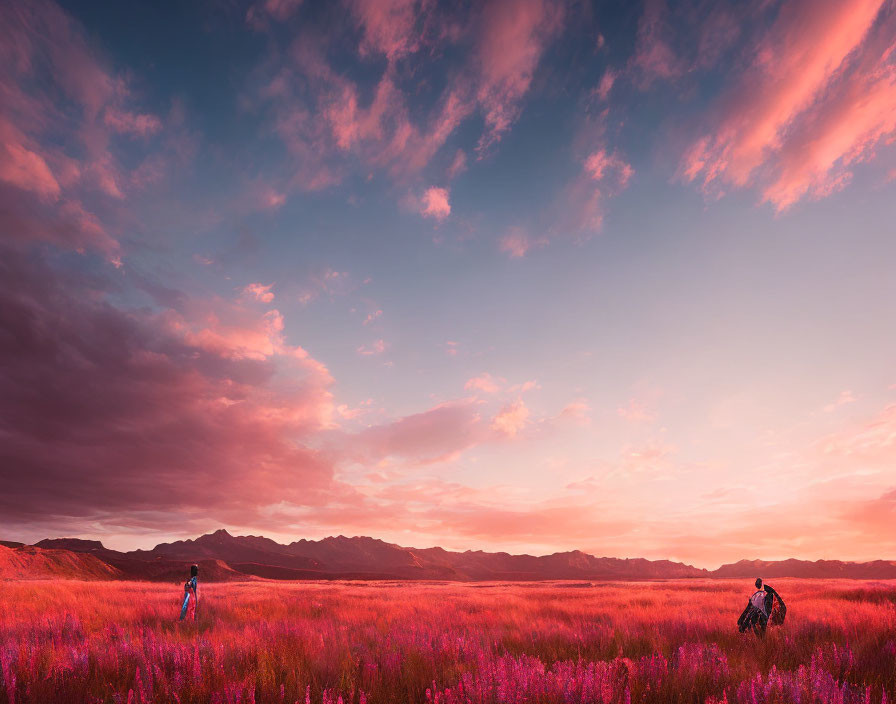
left=476, top=0, right=564, bottom=153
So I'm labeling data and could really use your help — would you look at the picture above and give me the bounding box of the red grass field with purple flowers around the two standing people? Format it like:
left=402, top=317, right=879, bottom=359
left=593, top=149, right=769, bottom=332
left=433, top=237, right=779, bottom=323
left=0, top=579, right=896, bottom=704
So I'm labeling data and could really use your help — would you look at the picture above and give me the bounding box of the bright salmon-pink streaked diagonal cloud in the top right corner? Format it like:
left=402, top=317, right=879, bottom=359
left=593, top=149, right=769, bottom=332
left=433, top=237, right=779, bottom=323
left=681, top=0, right=896, bottom=211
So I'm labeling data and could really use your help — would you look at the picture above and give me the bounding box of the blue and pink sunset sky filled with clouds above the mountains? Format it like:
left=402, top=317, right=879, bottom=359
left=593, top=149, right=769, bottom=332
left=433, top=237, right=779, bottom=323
left=0, top=0, right=896, bottom=568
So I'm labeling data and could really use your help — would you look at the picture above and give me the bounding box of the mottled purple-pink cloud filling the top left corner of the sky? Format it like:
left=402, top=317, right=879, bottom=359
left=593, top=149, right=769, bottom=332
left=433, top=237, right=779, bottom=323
left=0, top=0, right=189, bottom=261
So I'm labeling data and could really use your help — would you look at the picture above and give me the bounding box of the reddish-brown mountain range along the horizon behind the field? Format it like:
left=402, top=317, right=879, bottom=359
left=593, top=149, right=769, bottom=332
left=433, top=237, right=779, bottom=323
left=0, top=529, right=896, bottom=581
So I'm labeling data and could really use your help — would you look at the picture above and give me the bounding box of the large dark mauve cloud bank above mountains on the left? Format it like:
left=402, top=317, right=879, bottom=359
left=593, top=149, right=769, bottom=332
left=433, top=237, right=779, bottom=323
left=0, top=250, right=352, bottom=527
